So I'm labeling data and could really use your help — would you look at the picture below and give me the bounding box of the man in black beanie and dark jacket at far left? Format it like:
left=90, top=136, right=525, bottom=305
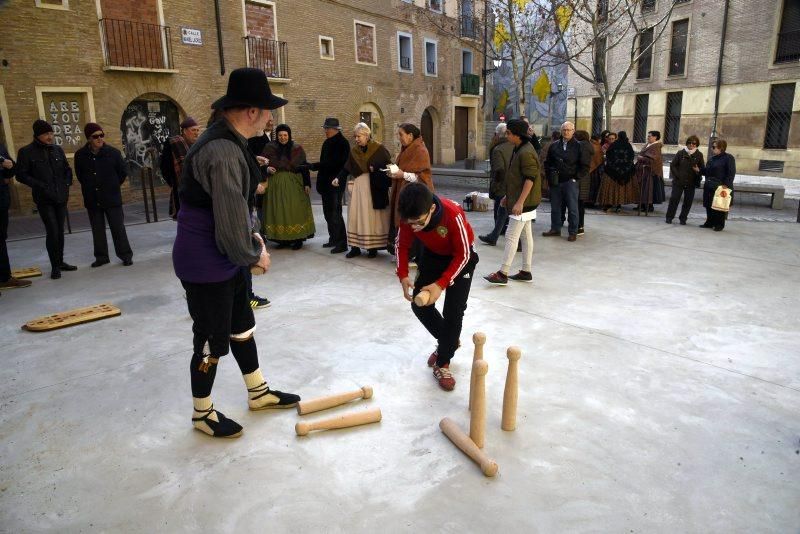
left=17, top=119, right=78, bottom=279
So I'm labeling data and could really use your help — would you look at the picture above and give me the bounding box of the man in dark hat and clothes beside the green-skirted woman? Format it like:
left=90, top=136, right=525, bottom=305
left=311, top=117, right=350, bottom=254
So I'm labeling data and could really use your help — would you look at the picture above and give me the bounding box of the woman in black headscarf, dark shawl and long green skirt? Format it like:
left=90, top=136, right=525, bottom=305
left=263, top=124, right=315, bottom=250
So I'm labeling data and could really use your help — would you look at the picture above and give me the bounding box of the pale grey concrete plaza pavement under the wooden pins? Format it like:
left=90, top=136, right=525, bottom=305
left=0, top=206, right=800, bottom=533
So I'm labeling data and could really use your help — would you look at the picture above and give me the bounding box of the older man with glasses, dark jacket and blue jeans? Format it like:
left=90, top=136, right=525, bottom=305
left=542, top=122, right=591, bottom=241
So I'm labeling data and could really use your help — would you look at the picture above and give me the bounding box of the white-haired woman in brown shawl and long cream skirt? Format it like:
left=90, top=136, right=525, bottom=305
left=333, top=122, right=392, bottom=258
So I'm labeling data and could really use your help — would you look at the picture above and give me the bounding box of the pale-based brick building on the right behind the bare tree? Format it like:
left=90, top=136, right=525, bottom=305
left=567, top=0, right=800, bottom=177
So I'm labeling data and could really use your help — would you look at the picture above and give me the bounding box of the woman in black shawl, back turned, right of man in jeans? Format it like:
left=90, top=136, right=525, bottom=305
left=597, top=132, right=639, bottom=213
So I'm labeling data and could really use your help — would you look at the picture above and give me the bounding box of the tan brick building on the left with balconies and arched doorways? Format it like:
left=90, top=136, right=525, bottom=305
left=0, top=0, right=485, bottom=213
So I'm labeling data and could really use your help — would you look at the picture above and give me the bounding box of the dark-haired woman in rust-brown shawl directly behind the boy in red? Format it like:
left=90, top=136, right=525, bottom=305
left=386, top=123, right=433, bottom=259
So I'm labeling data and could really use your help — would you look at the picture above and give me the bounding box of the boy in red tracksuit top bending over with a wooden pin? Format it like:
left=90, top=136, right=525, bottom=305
left=395, top=183, right=478, bottom=391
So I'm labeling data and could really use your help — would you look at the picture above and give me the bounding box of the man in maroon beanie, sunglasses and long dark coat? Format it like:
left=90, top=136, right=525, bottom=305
left=75, top=122, right=133, bottom=267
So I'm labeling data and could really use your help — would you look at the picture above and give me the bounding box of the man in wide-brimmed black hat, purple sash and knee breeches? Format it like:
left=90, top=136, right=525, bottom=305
left=172, top=68, right=300, bottom=438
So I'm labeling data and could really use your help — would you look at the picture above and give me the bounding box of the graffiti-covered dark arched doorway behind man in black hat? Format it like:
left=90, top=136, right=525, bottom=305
left=120, top=93, right=180, bottom=181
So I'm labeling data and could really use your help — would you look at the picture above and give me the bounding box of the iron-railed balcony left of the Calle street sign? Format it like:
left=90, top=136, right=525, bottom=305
left=99, top=19, right=173, bottom=72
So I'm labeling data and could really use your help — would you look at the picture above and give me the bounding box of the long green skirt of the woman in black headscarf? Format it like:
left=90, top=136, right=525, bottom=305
left=264, top=171, right=315, bottom=241
